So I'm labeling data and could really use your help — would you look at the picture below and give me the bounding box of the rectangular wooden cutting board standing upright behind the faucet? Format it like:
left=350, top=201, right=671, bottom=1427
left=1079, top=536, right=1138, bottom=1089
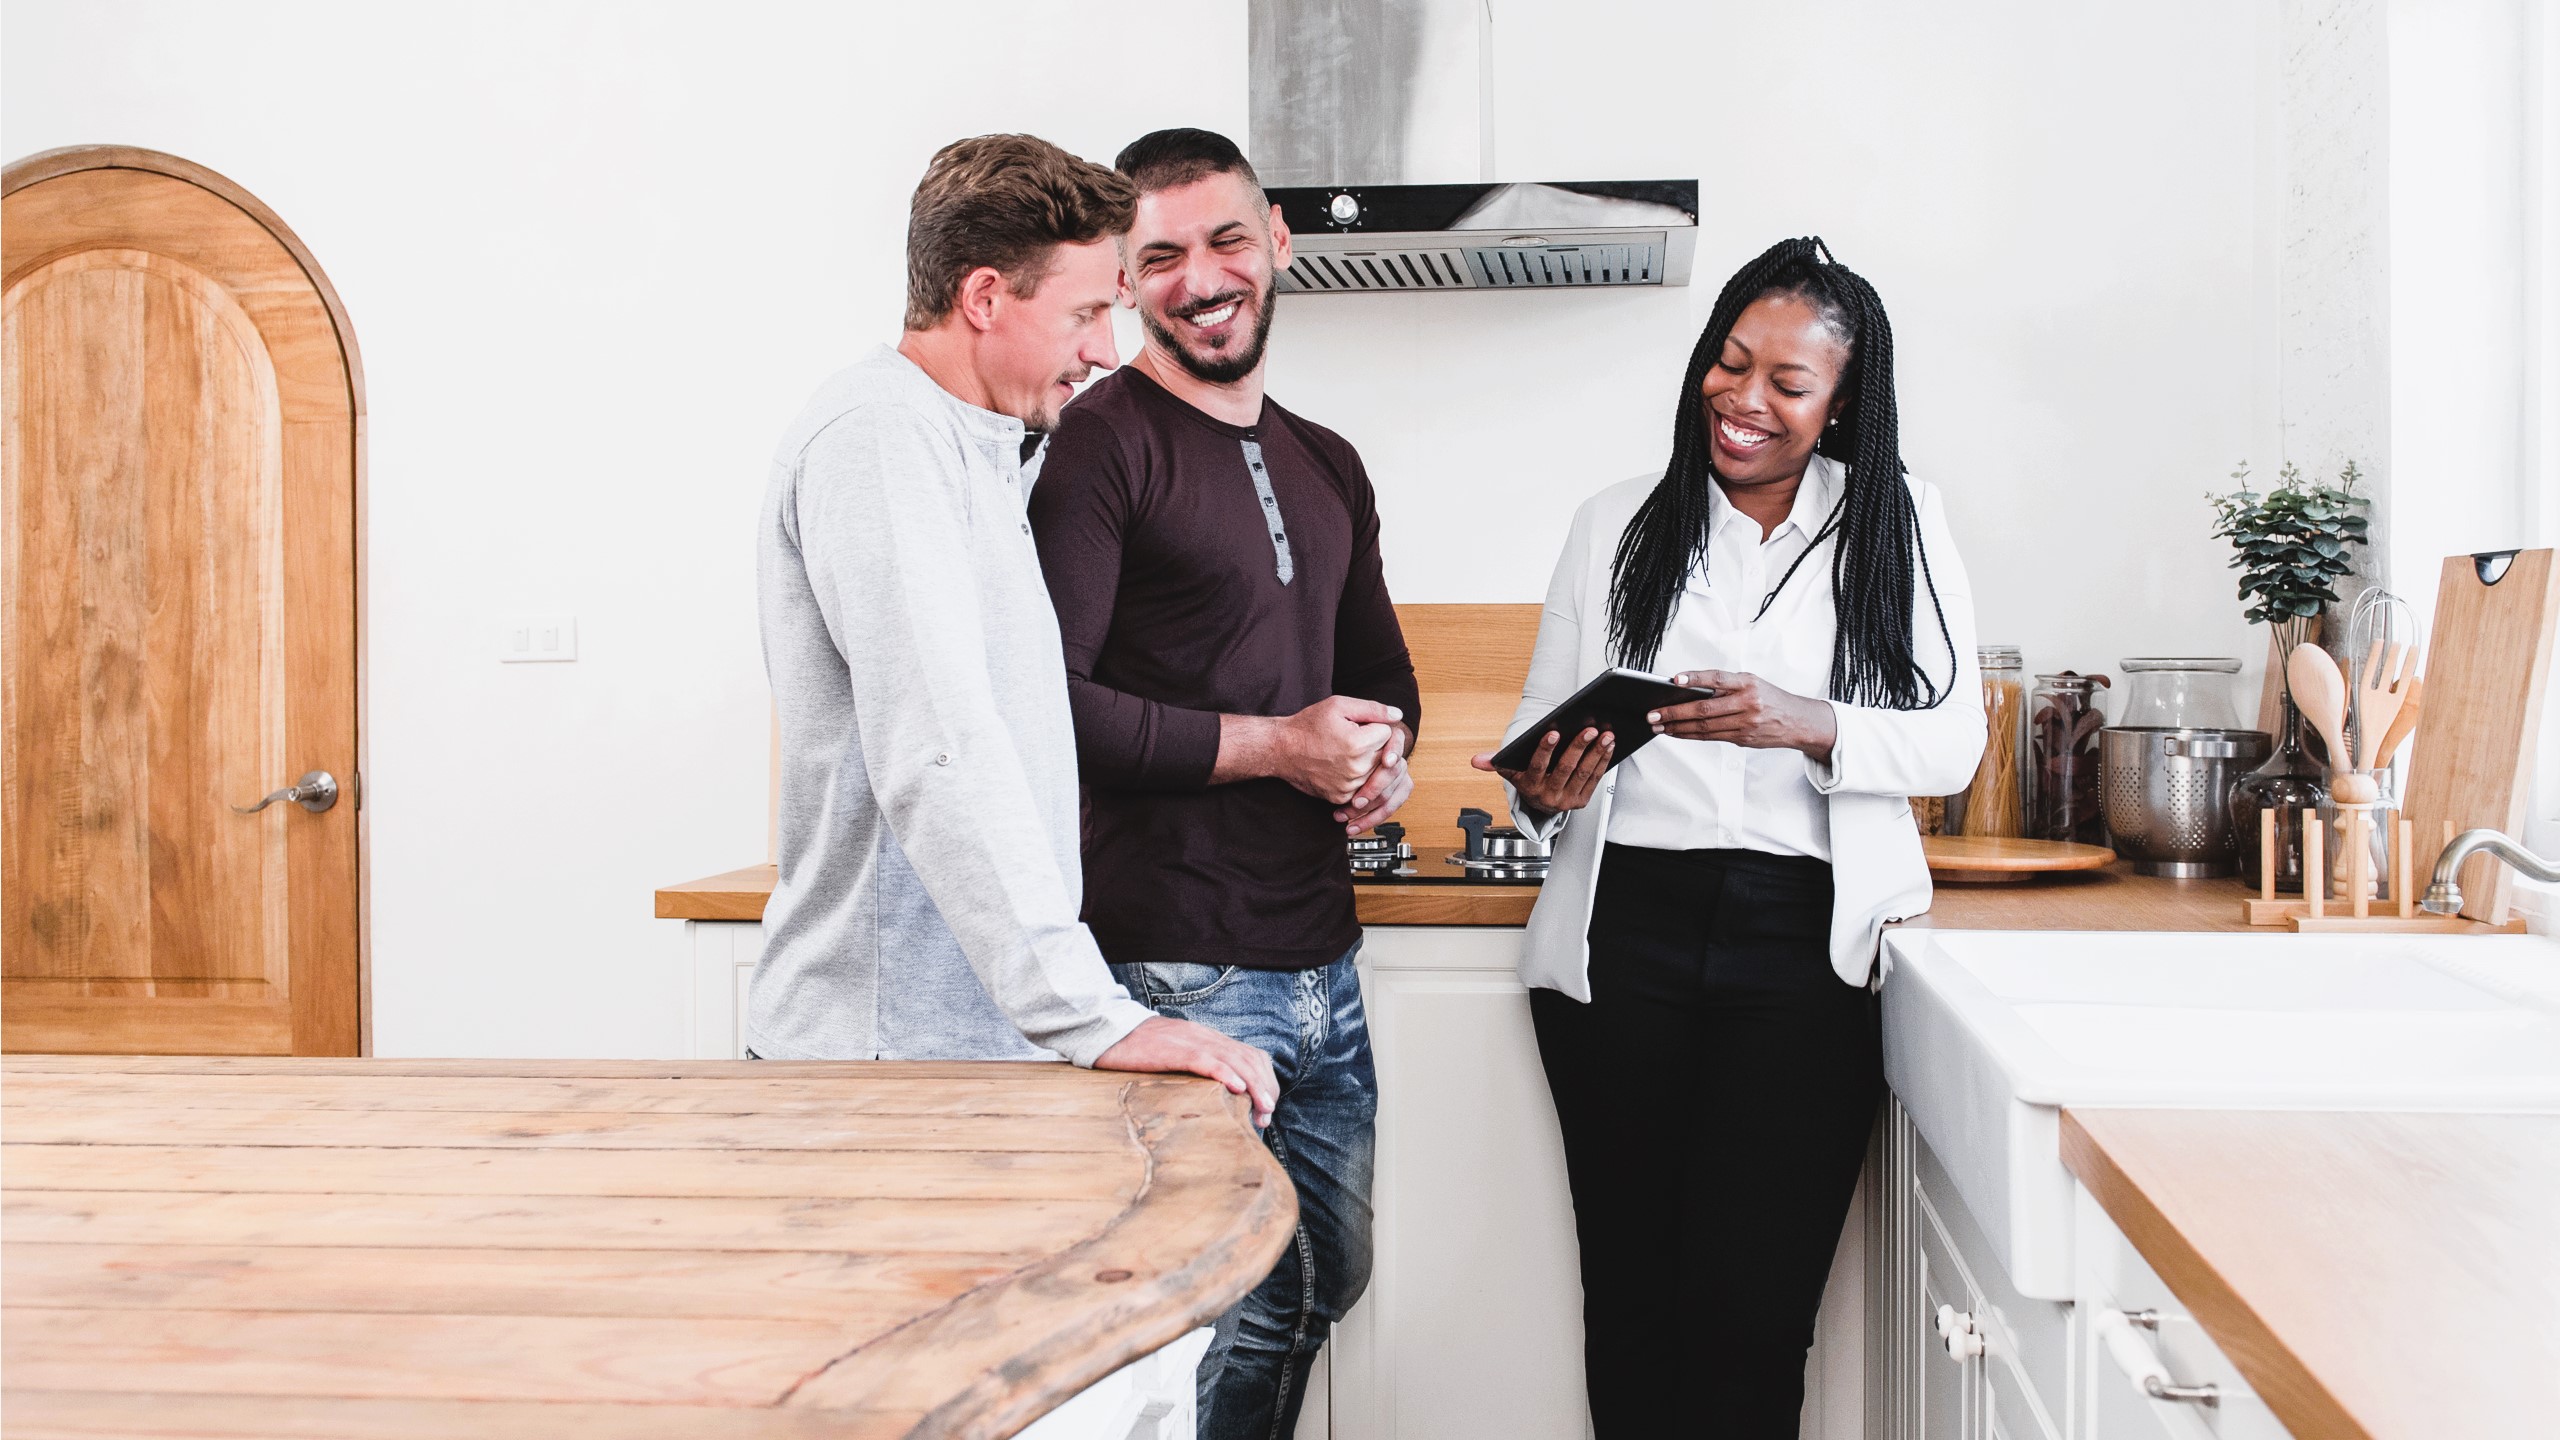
left=2406, top=551, right=2560, bottom=925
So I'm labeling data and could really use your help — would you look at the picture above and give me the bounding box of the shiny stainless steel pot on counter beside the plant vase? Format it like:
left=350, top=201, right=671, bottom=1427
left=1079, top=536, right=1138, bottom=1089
left=2099, top=725, right=2271, bottom=879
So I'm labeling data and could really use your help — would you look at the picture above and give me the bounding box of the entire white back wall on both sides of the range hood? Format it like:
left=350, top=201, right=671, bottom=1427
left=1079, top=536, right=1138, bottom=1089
left=0, top=0, right=2281, bottom=1056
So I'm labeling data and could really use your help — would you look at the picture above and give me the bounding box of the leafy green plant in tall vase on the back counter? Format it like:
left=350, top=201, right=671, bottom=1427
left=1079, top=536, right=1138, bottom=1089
left=2207, top=461, right=2371, bottom=894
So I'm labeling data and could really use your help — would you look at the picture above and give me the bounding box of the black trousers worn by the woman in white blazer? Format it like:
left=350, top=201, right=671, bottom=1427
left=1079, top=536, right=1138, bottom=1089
left=1528, top=846, right=1884, bottom=1440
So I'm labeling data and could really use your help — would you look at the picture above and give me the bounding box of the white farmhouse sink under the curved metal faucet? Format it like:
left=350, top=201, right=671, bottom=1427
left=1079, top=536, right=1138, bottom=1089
left=1884, top=930, right=2560, bottom=1299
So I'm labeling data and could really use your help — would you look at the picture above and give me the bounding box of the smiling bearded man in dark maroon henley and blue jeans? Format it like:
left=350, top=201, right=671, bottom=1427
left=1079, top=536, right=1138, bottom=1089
left=1029, top=131, right=1421, bottom=1440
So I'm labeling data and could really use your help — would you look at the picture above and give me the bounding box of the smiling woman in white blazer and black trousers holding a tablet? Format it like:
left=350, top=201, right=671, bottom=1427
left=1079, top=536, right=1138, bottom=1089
left=1477, top=238, right=1984, bottom=1440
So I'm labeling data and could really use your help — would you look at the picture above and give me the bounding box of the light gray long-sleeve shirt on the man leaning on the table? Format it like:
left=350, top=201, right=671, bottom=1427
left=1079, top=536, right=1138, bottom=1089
left=748, top=348, right=1149, bottom=1066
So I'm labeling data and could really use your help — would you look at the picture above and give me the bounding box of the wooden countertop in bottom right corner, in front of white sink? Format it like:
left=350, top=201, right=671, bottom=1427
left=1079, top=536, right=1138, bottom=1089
left=2063, top=1109, right=2560, bottom=1440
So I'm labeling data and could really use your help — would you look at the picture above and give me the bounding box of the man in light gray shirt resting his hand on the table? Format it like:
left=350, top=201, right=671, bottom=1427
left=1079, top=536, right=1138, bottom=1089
left=748, top=136, right=1277, bottom=1122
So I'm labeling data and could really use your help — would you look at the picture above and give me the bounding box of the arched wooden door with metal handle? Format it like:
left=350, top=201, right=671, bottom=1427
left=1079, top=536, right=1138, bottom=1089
left=0, top=146, right=364, bottom=1056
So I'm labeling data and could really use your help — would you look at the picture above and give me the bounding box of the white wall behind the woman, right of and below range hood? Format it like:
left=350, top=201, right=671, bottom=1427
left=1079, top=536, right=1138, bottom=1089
left=1272, top=0, right=2276, bottom=671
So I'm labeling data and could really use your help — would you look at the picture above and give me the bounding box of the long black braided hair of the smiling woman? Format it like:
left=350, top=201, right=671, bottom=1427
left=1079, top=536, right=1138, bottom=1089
left=1608, top=236, right=1956, bottom=710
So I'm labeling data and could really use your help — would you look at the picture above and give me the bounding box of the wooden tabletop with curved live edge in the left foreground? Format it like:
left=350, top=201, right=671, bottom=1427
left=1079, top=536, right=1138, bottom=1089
left=0, top=1056, right=1298, bottom=1440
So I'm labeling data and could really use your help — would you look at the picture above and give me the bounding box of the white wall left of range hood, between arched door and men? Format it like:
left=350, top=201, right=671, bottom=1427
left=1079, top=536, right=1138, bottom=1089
left=0, top=0, right=1244, bottom=1056
